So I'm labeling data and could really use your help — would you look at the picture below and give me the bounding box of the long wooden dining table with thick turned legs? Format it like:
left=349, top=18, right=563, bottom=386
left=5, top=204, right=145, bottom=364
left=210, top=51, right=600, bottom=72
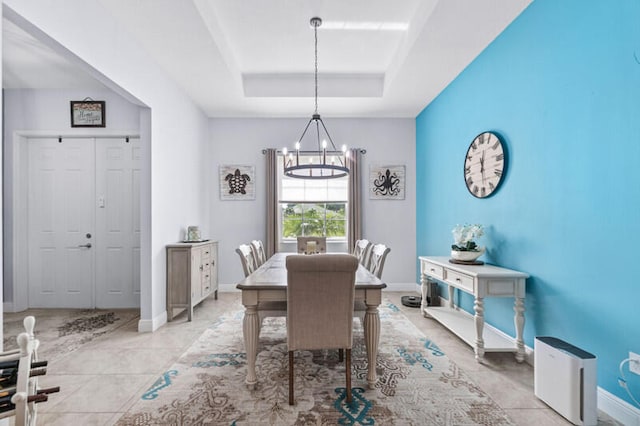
left=236, top=252, right=387, bottom=389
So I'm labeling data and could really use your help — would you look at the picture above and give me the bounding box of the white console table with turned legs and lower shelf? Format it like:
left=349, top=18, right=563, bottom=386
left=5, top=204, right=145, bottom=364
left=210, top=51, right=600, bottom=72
left=420, top=256, right=529, bottom=362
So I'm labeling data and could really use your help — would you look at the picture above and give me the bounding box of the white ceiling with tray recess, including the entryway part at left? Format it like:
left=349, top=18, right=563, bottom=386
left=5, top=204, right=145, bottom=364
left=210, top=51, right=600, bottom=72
left=3, top=0, right=532, bottom=117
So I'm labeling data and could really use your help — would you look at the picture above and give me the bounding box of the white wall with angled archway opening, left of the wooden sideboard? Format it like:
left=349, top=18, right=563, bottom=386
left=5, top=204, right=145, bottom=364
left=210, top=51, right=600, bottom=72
left=3, top=0, right=210, bottom=331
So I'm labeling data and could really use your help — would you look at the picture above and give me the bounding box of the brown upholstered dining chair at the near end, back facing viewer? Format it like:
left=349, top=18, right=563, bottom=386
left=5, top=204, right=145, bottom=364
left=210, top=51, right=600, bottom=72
left=286, top=254, right=358, bottom=405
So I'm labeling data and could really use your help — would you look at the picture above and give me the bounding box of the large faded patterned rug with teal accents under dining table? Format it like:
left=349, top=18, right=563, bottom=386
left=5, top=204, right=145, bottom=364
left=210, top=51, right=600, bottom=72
left=117, top=303, right=513, bottom=426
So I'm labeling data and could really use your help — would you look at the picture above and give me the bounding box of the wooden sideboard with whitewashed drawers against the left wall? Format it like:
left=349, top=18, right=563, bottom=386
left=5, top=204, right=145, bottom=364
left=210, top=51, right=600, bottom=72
left=167, top=241, right=218, bottom=321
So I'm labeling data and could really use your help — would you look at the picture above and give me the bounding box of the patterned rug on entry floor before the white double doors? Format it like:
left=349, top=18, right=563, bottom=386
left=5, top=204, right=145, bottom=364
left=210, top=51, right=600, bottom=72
left=3, top=309, right=140, bottom=361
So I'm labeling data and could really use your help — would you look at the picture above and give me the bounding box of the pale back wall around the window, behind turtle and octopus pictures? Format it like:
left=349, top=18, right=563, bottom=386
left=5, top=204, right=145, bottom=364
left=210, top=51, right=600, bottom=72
left=212, top=118, right=416, bottom=290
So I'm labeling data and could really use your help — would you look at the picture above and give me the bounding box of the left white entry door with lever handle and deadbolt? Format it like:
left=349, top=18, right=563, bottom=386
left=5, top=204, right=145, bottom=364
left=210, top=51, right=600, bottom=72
left=27, top=138, right=95, bottom=308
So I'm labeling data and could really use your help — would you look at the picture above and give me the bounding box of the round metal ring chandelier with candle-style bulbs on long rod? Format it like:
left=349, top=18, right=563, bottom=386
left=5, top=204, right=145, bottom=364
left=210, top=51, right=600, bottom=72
left=282, top=17, right=349, bottom=179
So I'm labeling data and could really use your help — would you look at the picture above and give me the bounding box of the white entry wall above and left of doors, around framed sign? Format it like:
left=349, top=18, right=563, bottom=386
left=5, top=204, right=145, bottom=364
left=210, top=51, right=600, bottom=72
left=3, top=89, right=140, bottom=303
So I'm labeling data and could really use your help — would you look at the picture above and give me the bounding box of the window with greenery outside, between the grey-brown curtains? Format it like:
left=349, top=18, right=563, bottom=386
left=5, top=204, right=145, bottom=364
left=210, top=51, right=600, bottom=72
left=278, top=154, right=349, bottom=240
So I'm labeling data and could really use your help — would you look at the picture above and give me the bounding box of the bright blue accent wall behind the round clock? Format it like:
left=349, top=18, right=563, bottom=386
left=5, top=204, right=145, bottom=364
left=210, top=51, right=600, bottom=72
left=416, top=0, right=640, bottom=401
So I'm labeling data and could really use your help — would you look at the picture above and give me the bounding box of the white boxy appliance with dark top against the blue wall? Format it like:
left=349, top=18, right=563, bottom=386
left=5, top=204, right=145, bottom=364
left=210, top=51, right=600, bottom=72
left=534, top=336, right=598, bottom=426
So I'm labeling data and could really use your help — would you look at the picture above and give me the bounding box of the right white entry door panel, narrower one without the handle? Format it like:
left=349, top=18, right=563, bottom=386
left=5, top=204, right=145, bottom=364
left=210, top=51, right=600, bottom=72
left=96, top=138, right=140, bottom=308
